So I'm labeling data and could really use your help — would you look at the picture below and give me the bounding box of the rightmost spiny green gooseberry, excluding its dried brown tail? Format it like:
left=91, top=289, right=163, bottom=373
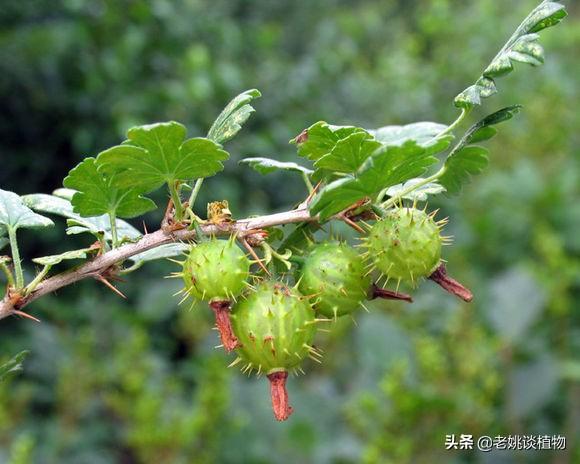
left=366, top=208, right=445, bottom=285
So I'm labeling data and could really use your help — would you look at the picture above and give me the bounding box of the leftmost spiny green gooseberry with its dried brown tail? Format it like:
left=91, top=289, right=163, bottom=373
left=182, top=237, right=250, bottom=351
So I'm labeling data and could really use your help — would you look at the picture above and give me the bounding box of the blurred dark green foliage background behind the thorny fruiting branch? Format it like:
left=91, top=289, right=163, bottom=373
left=0, top=0, right=580, bottom=464
